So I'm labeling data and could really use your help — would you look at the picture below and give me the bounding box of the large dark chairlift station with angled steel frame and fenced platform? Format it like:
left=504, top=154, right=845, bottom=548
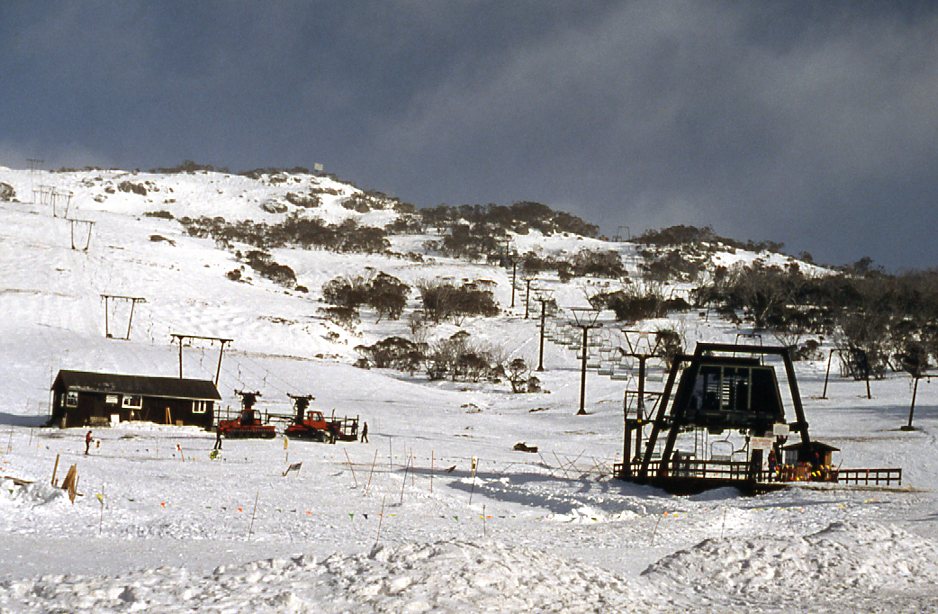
left=615, top=343, right=902, bottom=494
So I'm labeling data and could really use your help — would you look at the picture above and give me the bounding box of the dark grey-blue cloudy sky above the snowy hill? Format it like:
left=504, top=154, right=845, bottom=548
left=0, top=0, right=938, bottom=269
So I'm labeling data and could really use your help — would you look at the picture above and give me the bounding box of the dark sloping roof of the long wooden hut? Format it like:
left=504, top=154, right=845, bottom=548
left=52, top=369, right=221, bottom=401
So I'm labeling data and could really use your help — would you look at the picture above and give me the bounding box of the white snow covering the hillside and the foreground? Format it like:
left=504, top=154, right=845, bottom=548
left=0, top=168, right=938, bottom=612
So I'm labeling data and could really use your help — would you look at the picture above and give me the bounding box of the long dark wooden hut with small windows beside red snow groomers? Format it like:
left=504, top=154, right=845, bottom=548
left=51, top=370, right=221, bottom=429
